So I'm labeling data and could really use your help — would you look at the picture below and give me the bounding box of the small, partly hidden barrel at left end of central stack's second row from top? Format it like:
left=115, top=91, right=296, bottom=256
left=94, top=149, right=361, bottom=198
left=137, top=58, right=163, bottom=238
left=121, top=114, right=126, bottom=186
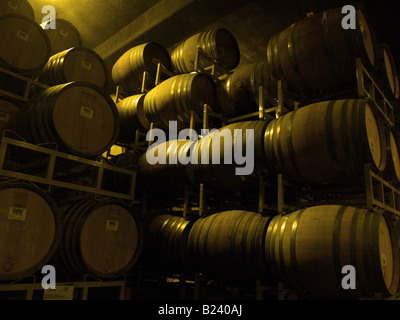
left=117, top=94, right=151, bottom=142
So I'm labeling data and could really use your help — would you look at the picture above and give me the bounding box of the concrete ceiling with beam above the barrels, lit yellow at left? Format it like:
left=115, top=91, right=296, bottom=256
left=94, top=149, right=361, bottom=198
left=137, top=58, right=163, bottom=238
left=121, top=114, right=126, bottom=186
left=29, top=0, right=400, bottom=91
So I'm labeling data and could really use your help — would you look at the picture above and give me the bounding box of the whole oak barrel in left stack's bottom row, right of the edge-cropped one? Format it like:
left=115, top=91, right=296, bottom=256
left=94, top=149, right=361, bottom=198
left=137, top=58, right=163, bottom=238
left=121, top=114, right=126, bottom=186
left=57, top=198, right=143, bottom=279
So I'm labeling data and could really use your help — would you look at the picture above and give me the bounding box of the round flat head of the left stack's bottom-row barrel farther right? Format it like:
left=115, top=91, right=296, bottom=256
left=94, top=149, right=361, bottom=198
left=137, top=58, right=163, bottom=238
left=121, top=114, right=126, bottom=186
left=79, top=204, right=142, bottom=278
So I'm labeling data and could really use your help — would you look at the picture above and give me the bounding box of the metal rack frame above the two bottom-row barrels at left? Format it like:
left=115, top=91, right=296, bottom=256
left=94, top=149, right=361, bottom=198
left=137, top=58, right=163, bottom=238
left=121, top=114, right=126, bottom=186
left=0, top=130, right=136, bottom=201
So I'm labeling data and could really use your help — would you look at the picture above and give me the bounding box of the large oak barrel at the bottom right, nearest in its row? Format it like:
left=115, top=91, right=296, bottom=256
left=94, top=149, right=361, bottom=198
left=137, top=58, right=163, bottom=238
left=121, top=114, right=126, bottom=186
left=265, top=205, right=400, bottom=299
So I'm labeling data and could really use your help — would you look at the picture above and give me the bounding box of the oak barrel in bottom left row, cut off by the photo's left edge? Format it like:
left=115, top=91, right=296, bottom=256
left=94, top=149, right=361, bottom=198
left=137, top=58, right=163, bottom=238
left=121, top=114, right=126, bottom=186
left=0, top=183, right=62, bottom=281
